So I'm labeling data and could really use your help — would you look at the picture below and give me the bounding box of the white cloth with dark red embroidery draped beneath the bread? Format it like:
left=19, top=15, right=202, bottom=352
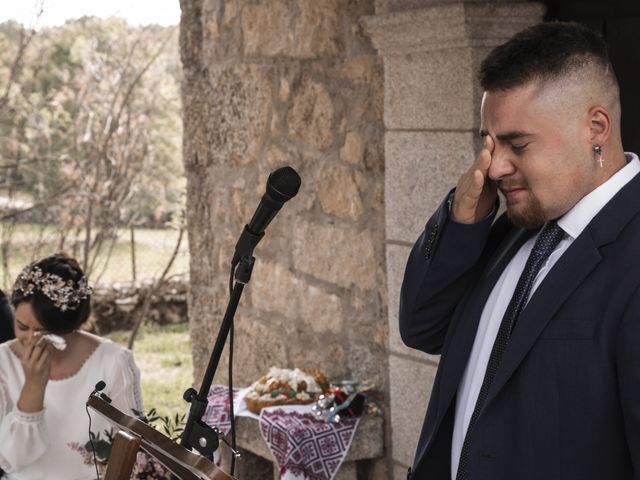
left=203, top=385, right=360, bottom=480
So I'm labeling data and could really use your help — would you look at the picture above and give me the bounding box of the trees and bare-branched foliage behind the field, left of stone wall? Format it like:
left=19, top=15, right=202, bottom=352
left=0, top=17, right=185, bottom=278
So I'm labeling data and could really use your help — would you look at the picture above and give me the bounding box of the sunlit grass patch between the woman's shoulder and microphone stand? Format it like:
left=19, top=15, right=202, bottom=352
left=107, top=324, right=193, bottom=418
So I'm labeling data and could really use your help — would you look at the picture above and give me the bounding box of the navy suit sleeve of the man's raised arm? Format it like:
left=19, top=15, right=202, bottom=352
left=399, top=192, right=498, bottom=354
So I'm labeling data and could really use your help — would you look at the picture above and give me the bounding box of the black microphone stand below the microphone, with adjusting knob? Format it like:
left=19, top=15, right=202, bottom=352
left=180, top=253, right=255, bottom=457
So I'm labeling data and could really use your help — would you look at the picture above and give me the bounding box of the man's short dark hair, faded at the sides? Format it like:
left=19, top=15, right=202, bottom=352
left=480, top=22, right=617, bottom=92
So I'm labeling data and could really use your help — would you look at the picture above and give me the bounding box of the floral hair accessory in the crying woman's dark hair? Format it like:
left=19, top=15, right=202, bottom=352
left=13, top=265, right=93, bottom=312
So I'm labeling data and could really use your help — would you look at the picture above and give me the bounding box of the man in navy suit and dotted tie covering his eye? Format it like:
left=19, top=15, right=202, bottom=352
left=400, top=23, right=640, bottom=480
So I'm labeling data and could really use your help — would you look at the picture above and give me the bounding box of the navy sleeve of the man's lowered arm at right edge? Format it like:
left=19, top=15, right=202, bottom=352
left=616, top=291, right=640, bottom=480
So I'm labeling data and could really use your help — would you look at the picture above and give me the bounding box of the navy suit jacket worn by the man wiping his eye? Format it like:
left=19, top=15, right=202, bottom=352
left=400, top=175, right=640, bottom=480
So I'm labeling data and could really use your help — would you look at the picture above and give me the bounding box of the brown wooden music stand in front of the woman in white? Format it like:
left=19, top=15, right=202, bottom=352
left=87, top=395, right=233, bottom=480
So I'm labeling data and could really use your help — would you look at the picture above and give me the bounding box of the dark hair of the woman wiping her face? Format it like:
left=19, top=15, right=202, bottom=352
left=11, top=253, right=91, bottom=334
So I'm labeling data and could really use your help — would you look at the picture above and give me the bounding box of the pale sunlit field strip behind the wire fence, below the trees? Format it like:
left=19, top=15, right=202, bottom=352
left=0, top=222, right=189, bottom=289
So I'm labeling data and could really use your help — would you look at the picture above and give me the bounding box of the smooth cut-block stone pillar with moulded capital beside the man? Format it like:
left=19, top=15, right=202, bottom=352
left=363, top=0, right=544, bottom=479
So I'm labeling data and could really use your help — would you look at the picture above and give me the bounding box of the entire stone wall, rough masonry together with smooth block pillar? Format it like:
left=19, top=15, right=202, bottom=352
left=181, top=0, right=544, bottom=479
